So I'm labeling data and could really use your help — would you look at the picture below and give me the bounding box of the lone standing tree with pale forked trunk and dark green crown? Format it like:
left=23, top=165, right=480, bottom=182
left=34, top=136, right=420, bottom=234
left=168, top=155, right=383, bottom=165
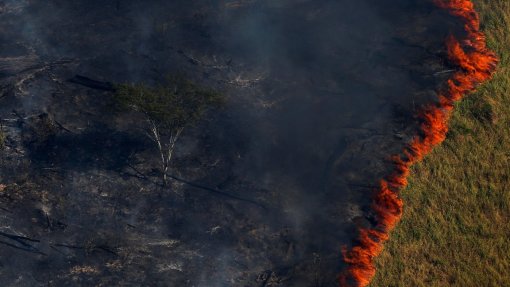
left=114, top=76, right=224, bottom=185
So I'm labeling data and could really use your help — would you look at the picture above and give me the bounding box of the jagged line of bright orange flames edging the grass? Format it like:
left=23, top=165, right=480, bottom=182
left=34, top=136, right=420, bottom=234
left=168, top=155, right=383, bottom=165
left=339, top=0, right=498, bottom=287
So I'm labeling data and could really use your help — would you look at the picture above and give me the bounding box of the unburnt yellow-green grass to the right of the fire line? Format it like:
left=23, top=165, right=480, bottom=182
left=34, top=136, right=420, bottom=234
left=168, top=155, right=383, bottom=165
left=371, top=0, right=510, bottom=287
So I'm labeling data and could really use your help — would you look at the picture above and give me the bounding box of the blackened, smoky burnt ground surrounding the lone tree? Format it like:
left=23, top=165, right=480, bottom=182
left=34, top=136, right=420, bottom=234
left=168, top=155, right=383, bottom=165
left=0, top=0, right=464, bottom=287
